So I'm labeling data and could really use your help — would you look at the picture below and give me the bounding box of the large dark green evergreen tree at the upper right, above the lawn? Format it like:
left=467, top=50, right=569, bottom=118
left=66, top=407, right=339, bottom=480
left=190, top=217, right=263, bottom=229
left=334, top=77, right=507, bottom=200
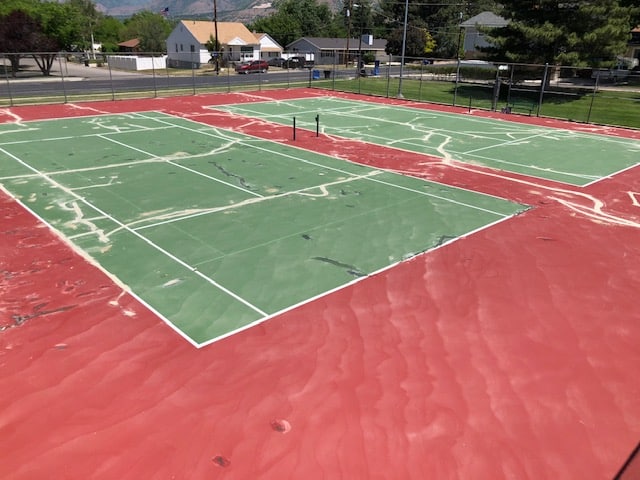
left=484, top=0, right=632, bottom=66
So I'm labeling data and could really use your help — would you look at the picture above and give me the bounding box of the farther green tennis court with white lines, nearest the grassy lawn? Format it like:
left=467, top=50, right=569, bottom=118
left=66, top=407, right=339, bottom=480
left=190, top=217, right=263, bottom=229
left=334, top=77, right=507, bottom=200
left=215, top=97, right=640, bottom=186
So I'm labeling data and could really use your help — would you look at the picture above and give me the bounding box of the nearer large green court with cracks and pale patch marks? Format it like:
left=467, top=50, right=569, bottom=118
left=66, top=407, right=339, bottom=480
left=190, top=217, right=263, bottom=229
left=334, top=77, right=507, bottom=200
left=0, top=111, right=526, bottom=346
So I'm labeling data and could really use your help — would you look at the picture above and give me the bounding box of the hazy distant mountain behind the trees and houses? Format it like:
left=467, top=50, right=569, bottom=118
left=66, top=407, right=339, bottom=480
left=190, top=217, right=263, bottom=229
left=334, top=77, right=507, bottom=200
left=96, top=0, right=342, bottom=23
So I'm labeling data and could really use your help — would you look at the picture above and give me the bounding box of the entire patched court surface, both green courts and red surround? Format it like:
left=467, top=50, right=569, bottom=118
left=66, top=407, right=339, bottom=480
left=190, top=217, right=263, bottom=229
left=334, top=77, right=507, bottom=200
left=0, top=89, right=640, bottom=480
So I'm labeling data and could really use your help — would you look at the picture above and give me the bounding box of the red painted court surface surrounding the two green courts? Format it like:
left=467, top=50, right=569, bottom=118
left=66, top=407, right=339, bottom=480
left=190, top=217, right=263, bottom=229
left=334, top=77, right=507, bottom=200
left=0, top=90, right=640, bottom=480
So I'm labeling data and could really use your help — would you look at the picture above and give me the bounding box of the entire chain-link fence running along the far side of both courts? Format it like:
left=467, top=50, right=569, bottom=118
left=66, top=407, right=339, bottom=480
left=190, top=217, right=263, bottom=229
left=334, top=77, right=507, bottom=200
left=0, top=53, right=640, bottom=128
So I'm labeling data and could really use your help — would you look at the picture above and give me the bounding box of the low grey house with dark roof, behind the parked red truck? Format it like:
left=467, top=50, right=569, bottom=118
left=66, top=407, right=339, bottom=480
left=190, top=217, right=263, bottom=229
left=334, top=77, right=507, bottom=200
left=287, top=35, right=388, bottom=65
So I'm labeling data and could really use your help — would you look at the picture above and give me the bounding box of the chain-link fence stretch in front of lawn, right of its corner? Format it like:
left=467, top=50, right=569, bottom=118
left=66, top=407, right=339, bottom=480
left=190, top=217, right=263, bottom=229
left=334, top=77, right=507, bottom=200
left=316, top=58, right=640, bottom=128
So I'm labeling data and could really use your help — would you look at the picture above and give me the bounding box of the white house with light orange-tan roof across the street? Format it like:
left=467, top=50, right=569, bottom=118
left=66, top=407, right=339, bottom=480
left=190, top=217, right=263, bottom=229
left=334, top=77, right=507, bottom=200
left=167, top=20, right=260, bottom=68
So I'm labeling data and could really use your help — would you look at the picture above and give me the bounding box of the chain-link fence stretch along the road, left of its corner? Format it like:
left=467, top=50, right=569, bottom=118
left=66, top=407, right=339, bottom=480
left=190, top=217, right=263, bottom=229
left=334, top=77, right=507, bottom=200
left=0, top=53, right=312, bottom=107
